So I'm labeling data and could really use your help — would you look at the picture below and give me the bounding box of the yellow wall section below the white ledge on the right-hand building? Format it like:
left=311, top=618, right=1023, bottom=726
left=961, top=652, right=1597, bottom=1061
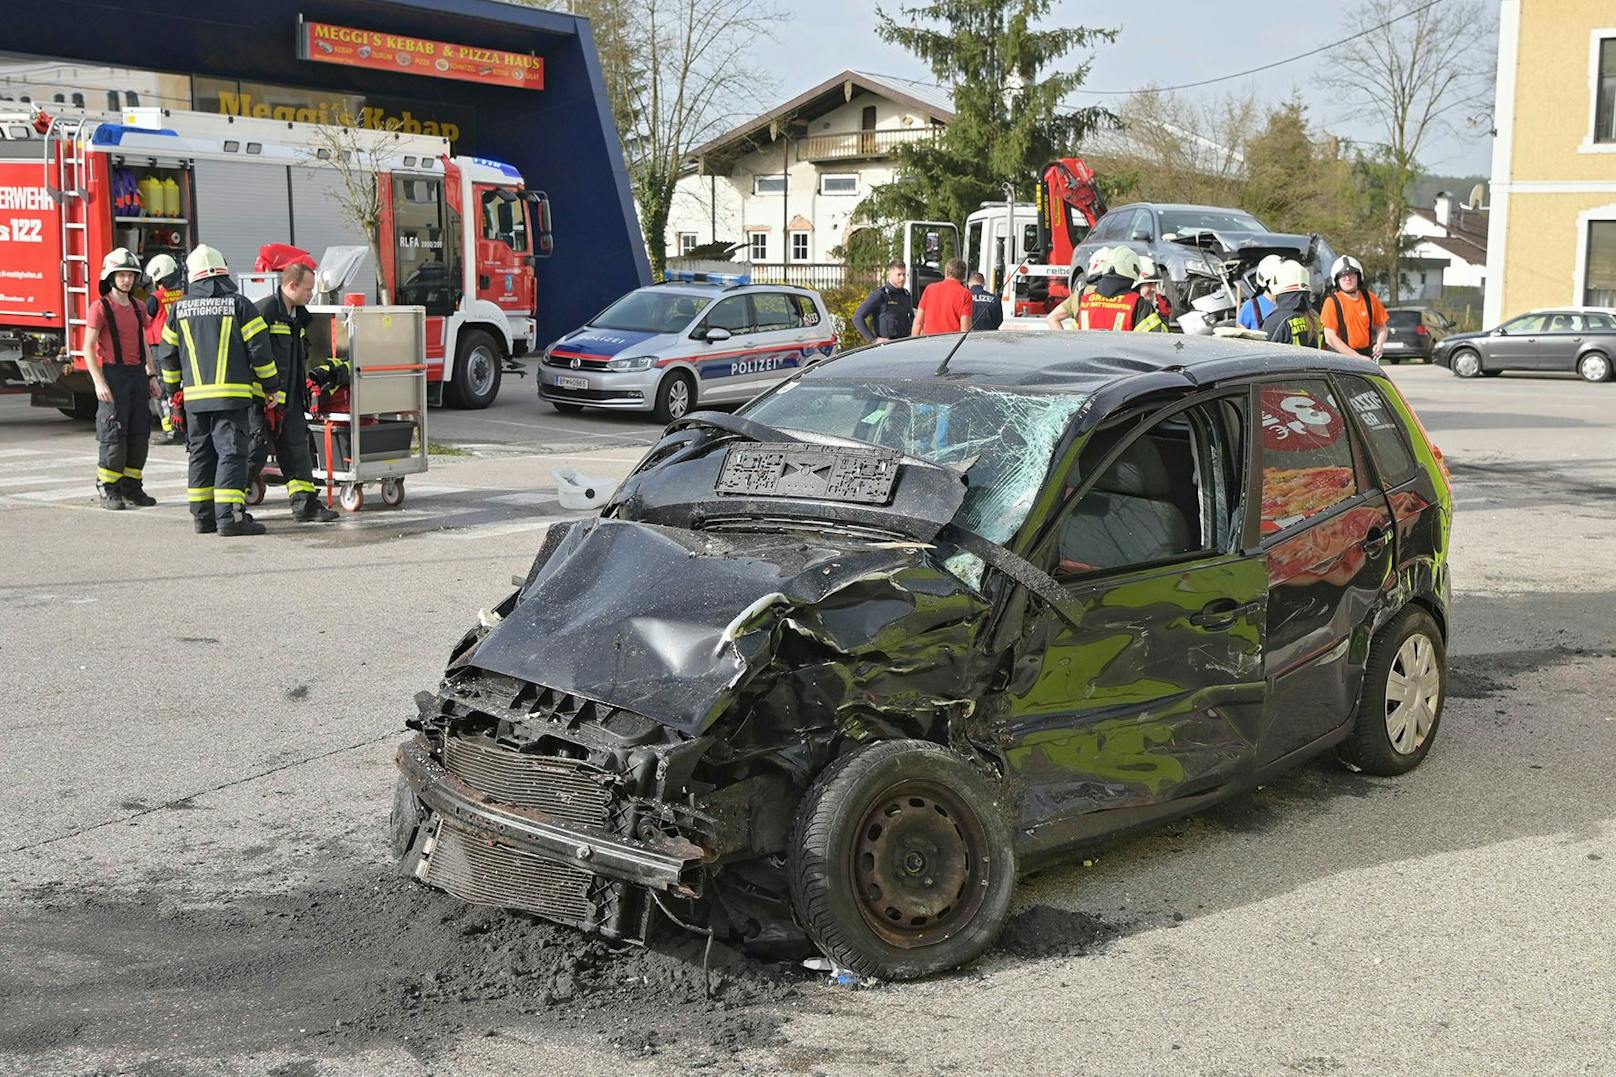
left=1487, top=191, right=1616, bottom=319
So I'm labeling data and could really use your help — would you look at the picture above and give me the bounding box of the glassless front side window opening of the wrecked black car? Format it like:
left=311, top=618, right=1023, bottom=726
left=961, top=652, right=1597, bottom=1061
left=1055, top=395, right=1246, bottom=577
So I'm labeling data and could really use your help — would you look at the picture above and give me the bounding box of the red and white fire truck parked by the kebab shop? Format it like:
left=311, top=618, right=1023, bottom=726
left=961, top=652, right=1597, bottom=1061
left=0, top=108, right=551, bottom=416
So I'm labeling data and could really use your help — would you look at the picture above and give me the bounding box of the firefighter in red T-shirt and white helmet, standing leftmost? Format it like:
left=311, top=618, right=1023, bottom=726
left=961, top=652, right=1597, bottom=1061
left=84, top=247, right=157, bottom=509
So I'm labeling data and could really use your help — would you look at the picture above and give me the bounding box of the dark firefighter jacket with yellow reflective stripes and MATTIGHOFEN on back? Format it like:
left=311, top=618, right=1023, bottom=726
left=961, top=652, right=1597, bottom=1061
left=160, top=277, right=280, bottom=411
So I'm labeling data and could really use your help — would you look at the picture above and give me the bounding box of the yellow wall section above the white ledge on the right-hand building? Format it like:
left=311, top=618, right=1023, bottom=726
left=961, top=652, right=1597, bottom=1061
left=1509, top=0, right=1616, bottom=183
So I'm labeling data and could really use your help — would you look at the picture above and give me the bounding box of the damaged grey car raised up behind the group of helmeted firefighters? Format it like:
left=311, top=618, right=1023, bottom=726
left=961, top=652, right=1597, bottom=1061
left=1073, top=202, right=1335, bottom=317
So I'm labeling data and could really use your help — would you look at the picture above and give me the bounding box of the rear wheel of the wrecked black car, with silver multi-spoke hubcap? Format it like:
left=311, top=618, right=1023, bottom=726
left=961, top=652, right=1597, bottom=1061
left=1336, top=606, right=1448, bottom=778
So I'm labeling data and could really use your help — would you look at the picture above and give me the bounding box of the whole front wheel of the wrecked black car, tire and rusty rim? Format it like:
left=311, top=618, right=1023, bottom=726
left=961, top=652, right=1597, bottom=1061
left=789, top=741, right=1015, bottom=980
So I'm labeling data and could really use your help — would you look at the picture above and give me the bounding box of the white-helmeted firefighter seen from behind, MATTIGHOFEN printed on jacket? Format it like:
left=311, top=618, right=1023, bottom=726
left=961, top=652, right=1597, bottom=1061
left=163, top=244, right=280, bottom=537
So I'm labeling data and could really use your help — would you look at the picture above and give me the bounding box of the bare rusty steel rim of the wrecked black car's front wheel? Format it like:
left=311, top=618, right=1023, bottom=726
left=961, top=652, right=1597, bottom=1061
left=850, top=781, right=989, bottom=949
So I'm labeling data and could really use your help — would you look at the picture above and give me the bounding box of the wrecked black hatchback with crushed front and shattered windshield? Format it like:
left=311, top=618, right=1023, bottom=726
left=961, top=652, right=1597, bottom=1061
left=393, top=333, right=1453, bottom=978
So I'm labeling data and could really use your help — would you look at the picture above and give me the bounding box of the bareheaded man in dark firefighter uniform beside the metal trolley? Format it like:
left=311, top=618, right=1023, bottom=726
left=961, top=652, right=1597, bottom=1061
left=249, top=262, right=338, bottom=524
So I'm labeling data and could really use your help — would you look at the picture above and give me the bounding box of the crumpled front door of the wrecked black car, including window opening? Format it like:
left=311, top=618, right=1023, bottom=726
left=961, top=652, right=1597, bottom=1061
left=1002, top=390, right=1269, bottom=849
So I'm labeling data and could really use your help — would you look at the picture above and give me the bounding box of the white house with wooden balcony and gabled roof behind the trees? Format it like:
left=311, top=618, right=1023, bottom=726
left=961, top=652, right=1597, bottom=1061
left=667, top=71, right=953, bottom=274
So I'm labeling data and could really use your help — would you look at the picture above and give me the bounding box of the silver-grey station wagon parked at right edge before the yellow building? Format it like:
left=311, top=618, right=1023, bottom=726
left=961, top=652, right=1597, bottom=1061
left=1432, top=307, right=1616, bottom=382
